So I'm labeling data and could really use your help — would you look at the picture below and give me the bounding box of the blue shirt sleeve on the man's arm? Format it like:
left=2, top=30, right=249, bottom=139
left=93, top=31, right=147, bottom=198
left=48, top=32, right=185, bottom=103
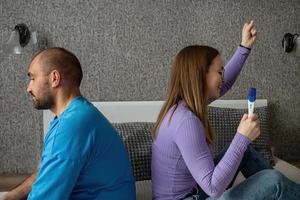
left=28, top=119, right=93, bottom=200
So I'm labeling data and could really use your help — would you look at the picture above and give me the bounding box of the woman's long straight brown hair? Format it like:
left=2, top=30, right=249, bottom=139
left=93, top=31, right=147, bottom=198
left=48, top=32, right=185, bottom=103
left=152, top=45, right=220, bottom=143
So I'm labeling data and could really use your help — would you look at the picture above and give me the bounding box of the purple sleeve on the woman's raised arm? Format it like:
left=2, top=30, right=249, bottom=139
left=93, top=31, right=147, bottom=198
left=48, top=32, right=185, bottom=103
left=221, top=46, right=250, bottom=96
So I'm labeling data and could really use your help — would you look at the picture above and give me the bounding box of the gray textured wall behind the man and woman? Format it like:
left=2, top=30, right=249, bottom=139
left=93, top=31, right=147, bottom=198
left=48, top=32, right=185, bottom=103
left=0, top=0, right=300, bottom=173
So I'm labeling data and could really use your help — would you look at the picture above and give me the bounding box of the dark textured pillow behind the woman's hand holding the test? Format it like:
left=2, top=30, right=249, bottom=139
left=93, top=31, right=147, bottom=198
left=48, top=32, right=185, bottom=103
left=208, top=106, right=274, bottom=165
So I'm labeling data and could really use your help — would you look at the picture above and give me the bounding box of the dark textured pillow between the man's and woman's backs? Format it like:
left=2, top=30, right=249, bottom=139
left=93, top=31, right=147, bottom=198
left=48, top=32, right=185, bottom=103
left=113, top=122, right=154, bottom=181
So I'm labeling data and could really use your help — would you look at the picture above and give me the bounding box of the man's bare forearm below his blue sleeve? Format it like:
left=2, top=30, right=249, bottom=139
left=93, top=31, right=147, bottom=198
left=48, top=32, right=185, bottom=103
left=0, top=173, right=37, bottom=200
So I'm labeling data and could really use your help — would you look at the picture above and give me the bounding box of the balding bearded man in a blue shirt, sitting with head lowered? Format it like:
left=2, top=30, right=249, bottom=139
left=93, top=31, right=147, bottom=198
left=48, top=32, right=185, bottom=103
left=3, top=48, right=135, bottom=200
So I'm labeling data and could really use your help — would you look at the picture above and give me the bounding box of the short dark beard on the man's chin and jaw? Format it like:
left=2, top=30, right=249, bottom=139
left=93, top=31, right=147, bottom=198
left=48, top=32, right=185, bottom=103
left=31, top=90, right=55, bottom=110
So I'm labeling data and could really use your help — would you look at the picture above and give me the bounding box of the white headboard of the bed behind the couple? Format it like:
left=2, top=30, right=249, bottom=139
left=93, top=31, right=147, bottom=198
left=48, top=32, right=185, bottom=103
left=43, top=99, right=267, bottom=136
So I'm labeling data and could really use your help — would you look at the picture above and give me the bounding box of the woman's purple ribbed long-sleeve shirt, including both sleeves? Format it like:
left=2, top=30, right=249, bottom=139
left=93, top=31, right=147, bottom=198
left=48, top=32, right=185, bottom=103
left=152, top=47, right=251, bottom=200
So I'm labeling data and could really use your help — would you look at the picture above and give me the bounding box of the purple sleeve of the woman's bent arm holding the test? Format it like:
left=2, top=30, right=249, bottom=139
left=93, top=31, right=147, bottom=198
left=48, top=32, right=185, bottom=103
left=174, top=117, right=250, bottom=197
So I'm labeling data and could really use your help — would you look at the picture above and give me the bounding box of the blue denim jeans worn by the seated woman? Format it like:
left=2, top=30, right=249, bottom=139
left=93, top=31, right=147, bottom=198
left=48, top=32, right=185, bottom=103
left=184, top=146, right=300, bottom=200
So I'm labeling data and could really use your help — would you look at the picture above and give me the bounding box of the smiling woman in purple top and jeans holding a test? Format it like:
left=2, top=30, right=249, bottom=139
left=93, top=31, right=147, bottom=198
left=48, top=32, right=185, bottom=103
left=152, top=21, right=300, bottom=199
